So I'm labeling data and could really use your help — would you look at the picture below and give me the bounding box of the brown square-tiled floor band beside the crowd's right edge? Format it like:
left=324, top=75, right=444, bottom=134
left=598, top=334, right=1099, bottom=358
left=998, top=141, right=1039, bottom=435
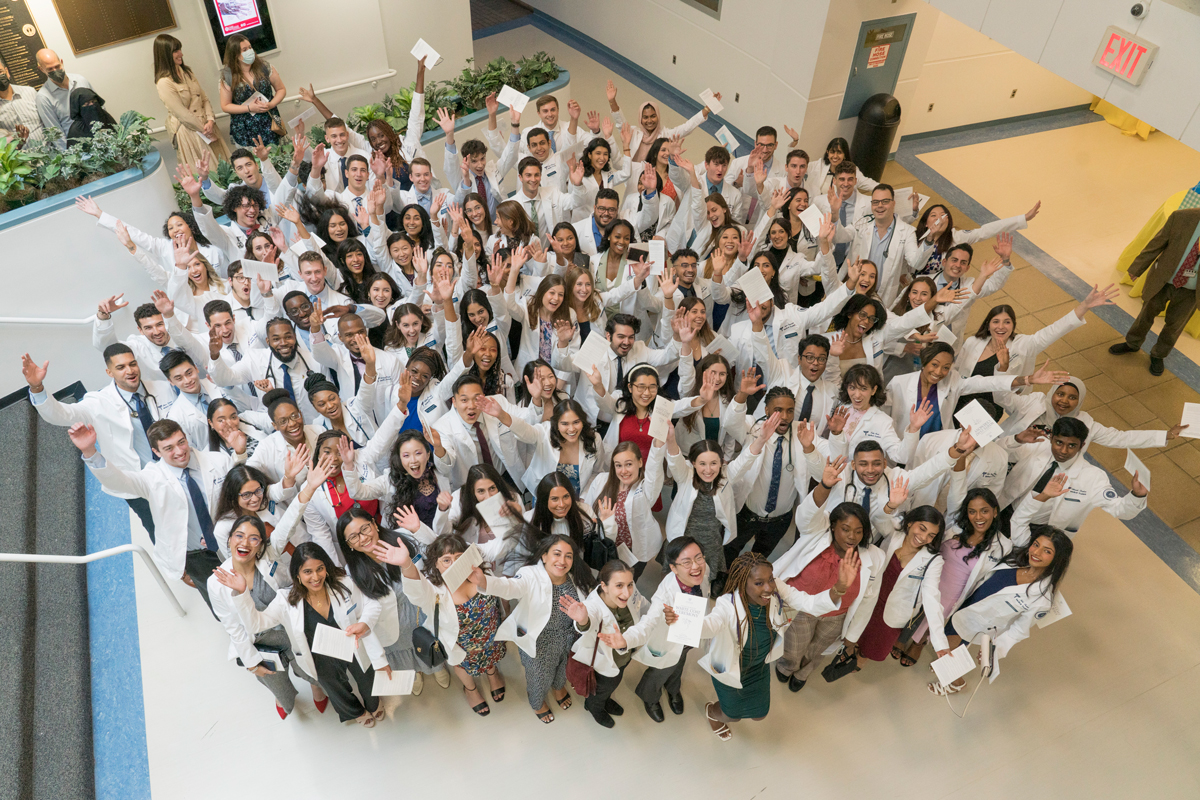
left=884, top=159, right=1200, bottom=549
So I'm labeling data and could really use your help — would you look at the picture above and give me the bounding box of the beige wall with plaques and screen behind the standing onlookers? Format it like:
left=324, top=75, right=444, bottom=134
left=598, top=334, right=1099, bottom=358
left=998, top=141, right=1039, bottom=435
left=29, top=0, right=474, bottom=143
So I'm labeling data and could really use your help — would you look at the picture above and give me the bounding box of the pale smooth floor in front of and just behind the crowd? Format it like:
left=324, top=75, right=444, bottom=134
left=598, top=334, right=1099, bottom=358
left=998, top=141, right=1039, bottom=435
left=121, top=28, right=1200, bottom=800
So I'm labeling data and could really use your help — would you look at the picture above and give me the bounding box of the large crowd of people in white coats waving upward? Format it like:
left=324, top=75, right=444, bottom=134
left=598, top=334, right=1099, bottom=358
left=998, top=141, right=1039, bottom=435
left=23, top=53, right=1182, bottom=740
